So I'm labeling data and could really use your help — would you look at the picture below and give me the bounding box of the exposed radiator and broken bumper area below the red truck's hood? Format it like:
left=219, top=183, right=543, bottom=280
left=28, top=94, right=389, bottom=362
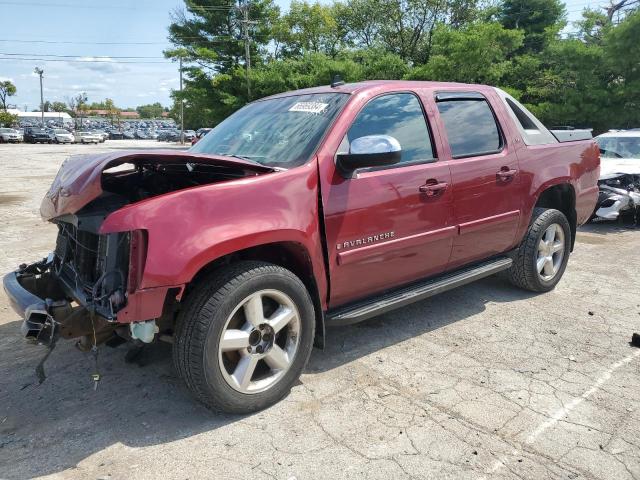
left=4, top=209, right=146, bottom=350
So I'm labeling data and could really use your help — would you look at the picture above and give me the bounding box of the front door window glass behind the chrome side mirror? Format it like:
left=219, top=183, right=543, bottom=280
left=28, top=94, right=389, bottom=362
left=340, top=93, right=434, bottom=163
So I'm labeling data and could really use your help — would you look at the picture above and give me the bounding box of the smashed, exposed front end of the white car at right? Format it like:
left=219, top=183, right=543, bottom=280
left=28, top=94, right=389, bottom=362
left=595, top=173, right=640, bottom=225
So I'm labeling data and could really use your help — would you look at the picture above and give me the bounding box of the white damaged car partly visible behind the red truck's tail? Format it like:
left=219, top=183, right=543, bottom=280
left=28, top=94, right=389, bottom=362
left=594, top=129, right=640, bottom=225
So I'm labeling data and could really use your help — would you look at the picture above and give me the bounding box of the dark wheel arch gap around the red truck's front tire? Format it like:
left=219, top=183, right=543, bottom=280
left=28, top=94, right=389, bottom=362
left=184, top=241, right=325, bottom=348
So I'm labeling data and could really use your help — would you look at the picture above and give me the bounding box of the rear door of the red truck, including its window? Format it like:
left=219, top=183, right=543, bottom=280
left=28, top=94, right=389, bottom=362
left=435, top=91, right=521, bottom=269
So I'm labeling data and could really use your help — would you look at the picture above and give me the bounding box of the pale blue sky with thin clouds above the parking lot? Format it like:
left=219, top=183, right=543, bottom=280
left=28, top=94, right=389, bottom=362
left=0, top=0, right=605, bottom=110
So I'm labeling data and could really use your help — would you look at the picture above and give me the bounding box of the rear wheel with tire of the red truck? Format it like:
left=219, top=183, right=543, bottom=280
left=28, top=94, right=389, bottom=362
left=506, top=208, right=571, bottom=292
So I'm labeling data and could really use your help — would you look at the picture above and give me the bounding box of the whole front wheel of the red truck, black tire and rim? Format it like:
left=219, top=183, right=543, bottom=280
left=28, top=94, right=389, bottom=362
left=173, top=261, right=315, bottom=413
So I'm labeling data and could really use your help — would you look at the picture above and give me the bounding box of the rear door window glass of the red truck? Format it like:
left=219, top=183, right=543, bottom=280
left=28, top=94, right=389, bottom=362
left=438, top=98, right=502, bottom=158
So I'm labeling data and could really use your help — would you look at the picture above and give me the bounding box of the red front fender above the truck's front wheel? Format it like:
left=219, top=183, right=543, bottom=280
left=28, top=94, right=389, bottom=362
left=100, top=161, right=327, bottom=298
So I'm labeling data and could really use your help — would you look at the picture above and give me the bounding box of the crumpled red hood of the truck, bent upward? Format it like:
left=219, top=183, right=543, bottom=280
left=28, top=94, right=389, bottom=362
left=40, top=150, right=273, bottom=220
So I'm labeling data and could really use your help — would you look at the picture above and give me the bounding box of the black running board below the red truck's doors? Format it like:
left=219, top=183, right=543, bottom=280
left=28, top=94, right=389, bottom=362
left=326, top=257, right=513, bottom=326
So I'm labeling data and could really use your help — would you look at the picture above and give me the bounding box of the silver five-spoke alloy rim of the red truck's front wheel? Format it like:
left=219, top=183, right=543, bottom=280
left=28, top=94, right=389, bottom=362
left=218, top=290, right=301, bottom=394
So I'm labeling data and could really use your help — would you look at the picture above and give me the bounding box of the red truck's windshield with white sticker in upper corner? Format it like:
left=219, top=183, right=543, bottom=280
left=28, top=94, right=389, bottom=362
left=190, top=93, right=349, bottom=168
